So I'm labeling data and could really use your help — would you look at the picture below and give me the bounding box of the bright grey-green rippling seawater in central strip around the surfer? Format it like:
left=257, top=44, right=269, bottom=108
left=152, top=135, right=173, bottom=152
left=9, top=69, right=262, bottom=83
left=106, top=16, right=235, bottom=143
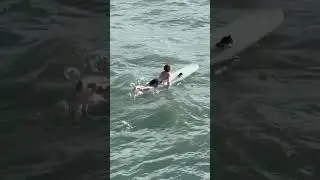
left=110, top=0, right=210, bottom=180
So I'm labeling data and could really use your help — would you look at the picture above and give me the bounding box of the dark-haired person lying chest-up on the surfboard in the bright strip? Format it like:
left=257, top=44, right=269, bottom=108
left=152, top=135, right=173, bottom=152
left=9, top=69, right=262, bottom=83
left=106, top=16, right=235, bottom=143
left=133, top=64, right=171, bottom=93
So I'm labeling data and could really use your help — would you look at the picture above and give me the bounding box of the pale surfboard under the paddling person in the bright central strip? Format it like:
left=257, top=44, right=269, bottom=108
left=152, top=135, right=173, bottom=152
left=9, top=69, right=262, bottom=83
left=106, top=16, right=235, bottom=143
left=132, top=64, right=199, bottom=97
